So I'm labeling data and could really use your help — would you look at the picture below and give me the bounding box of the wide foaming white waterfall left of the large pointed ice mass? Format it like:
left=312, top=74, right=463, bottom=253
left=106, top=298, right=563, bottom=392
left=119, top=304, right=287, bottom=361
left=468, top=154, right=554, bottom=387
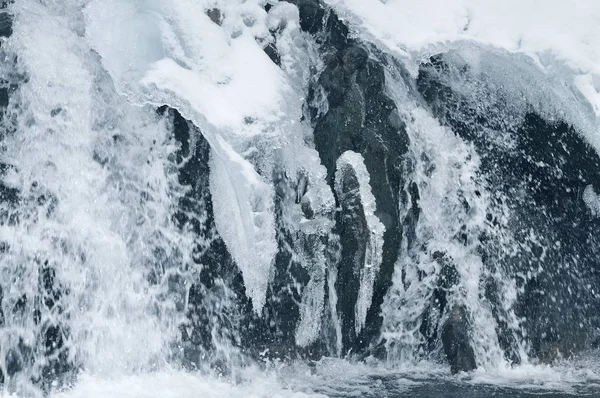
left=0, top=0, right=191, bottom=378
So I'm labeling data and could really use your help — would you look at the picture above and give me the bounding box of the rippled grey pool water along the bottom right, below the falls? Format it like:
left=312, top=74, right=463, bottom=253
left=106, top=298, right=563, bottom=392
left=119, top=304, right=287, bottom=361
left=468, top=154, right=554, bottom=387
left=278, top=355, right=600, bottom=398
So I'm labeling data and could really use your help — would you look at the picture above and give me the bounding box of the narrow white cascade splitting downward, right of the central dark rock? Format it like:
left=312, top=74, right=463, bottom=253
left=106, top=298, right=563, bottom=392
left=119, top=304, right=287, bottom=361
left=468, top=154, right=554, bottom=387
left=383, top=58, right=527, bottom=370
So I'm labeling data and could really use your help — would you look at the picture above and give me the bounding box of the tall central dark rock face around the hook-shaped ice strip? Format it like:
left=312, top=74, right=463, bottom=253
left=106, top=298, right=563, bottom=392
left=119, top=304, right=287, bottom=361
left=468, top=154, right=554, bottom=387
left=292, top=0, right=408, bottom=352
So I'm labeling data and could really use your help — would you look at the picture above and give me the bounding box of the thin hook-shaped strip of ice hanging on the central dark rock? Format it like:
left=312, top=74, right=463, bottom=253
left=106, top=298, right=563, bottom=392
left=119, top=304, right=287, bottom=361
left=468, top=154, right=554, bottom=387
left=335, top=151, right=385, bottom=332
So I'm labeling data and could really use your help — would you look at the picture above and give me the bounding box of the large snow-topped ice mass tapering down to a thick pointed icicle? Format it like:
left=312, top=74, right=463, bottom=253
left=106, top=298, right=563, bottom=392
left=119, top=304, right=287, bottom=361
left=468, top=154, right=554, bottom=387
left=85, top=0, right=290, bottom=312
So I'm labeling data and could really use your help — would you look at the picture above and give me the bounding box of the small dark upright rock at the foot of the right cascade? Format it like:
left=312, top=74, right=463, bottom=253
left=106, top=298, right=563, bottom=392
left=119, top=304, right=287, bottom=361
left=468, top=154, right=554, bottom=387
left=441, top=304, right=477, bottom=374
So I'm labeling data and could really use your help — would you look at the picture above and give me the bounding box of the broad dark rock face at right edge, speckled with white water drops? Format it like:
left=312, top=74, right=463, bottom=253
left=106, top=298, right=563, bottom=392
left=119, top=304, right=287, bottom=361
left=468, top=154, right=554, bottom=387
left=418, top=55, right=600, bottom=361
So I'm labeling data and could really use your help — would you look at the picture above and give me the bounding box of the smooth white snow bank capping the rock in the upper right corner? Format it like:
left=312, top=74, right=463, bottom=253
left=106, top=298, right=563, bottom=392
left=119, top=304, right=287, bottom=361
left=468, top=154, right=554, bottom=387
left=326, top=0, right=600, bottom=135
